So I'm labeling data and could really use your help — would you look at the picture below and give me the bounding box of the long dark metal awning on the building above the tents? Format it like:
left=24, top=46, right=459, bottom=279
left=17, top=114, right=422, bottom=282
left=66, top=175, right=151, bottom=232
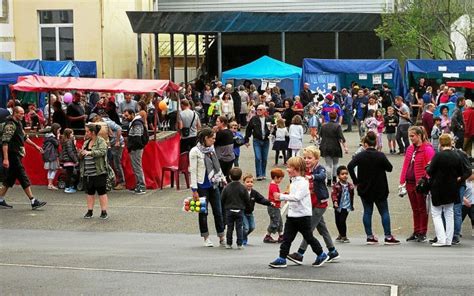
left=127, top=11, right=381, bottom=34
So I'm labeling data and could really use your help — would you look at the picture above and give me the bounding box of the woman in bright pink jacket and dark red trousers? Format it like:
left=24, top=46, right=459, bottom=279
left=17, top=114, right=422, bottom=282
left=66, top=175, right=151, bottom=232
left=400, top=126, right=435, bottom=242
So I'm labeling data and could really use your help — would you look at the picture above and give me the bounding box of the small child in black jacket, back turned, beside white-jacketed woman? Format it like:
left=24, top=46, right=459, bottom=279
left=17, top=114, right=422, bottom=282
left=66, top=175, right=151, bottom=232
left=222, top=168, right=250, bottom=250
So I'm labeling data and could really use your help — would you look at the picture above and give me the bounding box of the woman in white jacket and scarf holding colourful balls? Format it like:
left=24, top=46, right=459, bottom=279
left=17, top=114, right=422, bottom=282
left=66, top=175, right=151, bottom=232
left=189, top=128, right=225, bottom=247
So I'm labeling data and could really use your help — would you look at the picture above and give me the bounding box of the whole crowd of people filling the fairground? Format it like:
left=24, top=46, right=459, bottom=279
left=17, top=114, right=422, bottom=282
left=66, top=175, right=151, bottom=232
left=0, top=78, right=474, bottom=268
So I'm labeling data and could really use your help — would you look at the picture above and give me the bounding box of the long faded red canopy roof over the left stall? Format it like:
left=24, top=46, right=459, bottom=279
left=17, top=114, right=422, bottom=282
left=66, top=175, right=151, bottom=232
left=10, top=75, right=179, bottom=95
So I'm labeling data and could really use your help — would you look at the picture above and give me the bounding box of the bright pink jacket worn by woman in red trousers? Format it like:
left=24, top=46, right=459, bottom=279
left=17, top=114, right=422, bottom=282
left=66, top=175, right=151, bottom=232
left=400, top=143, right=435, bottom=184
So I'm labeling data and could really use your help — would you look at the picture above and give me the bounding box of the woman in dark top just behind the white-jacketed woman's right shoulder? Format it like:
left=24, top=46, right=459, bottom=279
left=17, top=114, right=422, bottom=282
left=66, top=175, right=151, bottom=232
left=214, top=115, right=235, bottom=178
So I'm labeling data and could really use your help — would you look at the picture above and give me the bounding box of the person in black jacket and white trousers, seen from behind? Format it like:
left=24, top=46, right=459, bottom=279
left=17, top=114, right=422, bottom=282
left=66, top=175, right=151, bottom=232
left=426, top=134, right=462, bottom=247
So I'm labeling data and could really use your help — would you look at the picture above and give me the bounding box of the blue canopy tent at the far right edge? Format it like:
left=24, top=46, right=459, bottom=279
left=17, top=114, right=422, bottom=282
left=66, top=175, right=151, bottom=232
left=405, top=60, right=474, bottom=93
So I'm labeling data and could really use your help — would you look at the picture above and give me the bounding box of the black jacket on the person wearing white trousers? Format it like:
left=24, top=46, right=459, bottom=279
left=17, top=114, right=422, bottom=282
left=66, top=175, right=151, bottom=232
left=426, top=150, right=462, bottom=206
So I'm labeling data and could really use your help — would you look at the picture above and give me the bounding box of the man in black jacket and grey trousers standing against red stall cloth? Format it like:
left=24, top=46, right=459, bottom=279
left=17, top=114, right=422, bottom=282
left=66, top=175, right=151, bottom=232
left=123, top=109, right=147, bottom=194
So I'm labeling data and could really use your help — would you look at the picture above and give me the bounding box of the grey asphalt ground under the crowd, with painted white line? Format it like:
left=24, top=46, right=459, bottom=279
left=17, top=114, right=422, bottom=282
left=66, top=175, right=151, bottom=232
left=0, top=133, right=474, bottom=295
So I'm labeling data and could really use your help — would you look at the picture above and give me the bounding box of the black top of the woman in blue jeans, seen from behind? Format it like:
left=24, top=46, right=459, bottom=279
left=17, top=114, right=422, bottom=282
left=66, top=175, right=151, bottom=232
left=347, top=148, right=393, bottom=201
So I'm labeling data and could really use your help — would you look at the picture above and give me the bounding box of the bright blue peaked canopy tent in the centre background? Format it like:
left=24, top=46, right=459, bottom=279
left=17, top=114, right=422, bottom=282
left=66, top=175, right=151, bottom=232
left=222, top=55, right=301, bottom=96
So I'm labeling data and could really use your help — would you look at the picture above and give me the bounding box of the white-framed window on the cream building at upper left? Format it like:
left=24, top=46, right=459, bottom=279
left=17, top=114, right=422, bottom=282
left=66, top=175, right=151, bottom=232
left=38, top=10, right=74, bottom=61
